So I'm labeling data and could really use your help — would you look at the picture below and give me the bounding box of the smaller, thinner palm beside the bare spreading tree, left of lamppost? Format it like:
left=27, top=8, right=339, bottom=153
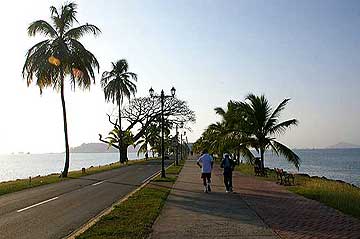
left=101, top=59, right=137, bottom=163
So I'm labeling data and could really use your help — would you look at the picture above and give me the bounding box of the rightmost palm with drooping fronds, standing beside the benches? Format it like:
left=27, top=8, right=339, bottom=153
left=237, top=94, right=300, bottom=170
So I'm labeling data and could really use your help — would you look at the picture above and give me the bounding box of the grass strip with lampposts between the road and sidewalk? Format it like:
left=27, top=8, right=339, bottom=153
left=76, top=161, right=183, bottom=239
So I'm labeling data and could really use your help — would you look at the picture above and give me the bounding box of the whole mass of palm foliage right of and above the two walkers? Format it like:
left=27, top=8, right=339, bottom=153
left=194, top=94, right=300, bottom=168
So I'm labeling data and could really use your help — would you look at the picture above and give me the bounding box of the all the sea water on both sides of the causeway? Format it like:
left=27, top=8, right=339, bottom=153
left=0, top=149, right=360, bottom=187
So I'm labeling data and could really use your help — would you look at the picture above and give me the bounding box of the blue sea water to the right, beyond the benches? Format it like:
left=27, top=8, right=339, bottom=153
left=258, top=149, right=360, bottom=187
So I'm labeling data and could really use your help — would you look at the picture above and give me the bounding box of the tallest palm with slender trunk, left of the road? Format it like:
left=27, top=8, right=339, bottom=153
left=22, top=3, right=100, bottom=177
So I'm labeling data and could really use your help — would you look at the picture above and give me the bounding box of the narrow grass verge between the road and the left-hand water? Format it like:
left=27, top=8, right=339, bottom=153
left=0, top=160, right=153, bottom=196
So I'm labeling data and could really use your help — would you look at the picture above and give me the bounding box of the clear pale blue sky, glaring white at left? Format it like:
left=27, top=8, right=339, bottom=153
left=0, top=0, right=360, bottom=153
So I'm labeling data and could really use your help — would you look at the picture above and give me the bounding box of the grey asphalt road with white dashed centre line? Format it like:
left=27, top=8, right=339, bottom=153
left=0, top=161, right=171, bottom=239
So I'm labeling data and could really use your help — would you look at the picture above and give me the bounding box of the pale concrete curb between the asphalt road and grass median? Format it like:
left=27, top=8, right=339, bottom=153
left=63, top=163, right=174, bottom=239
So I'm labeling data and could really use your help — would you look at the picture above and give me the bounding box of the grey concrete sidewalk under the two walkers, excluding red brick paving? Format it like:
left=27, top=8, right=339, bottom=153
left=150, top=160, right=279, bottom=239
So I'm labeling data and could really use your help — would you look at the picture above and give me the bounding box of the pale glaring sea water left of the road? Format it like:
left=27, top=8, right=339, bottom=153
left=0, top=153, right=144, bottom=182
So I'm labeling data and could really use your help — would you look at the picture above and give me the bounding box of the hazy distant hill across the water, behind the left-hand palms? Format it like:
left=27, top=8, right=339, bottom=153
left=70, top=143, right=138, bottom=153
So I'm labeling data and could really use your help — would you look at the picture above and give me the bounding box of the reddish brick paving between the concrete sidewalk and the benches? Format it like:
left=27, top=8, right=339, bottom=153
left=234, top=168, right=360, bottom=239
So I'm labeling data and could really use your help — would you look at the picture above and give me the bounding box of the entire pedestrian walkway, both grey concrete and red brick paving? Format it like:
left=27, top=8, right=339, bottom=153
left=150, top=161, right=360, bottom=239
